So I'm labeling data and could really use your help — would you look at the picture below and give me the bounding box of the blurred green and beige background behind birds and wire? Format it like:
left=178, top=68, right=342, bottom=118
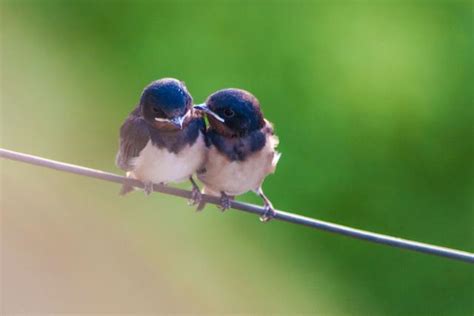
left=0, top=0, right=474, bottom=315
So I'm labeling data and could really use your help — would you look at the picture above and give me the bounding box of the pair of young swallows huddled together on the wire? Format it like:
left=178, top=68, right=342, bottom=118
left=116, top=78, right=280, bottom=221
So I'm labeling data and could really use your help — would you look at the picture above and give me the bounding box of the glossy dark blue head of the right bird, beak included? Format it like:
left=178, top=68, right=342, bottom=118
left=195, top=89, right=265, bottom=136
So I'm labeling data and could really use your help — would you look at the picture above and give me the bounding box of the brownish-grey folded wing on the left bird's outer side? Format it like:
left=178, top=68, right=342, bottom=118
left=115, top=110, right=150, bottom=171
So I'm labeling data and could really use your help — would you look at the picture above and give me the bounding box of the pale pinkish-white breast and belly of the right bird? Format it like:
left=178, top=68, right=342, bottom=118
left=198, top=136, right=280, bottom=195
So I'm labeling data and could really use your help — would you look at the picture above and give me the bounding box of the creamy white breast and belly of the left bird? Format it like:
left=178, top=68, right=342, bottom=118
left=130, top=133, right=206, bottom=183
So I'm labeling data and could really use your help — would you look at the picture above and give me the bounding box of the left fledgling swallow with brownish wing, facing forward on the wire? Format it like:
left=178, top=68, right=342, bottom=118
left=116, top=78, right=206, bottom=204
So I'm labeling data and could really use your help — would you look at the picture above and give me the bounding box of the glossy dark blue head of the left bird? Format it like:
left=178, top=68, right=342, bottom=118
left=140, top=78, right=193, bottom=128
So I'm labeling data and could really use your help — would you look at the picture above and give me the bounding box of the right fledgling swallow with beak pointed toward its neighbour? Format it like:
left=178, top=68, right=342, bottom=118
left=194, top=89, right=280, bottom=221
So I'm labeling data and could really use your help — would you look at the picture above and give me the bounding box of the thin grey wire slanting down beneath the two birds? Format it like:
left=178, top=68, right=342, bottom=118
left=0, top=148, right=474, bottom=263
